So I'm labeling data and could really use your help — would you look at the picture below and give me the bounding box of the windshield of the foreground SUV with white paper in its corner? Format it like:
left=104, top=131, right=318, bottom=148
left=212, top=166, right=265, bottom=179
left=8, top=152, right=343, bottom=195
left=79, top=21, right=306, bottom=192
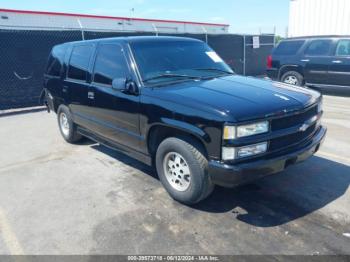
left=130, top=40, right=233, bottom=83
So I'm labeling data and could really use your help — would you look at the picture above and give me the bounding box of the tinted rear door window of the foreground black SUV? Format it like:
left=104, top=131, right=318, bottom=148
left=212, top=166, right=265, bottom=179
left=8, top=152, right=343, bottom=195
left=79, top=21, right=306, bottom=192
left=68, top=45, right=93, bottom=81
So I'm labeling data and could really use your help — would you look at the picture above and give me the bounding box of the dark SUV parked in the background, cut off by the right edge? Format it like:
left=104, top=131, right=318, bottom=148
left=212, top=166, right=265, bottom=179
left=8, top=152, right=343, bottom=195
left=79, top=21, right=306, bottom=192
left=267, top=36, right=350, bottom=87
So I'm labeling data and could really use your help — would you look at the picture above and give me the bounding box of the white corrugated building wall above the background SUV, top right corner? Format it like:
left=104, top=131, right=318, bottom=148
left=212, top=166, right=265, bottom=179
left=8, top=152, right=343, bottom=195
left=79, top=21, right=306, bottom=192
left=288, top=0, right=350, bottom=37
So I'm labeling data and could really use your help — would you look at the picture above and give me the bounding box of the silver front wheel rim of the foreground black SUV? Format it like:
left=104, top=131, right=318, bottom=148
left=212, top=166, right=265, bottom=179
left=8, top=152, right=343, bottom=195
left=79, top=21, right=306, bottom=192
left=163, top=152, right=191, bottom=191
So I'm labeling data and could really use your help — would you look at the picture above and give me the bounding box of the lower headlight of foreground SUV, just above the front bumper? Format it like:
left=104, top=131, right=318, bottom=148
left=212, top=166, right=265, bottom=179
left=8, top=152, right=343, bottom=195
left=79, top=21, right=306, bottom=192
left=222, top=142, right=267, bottom=160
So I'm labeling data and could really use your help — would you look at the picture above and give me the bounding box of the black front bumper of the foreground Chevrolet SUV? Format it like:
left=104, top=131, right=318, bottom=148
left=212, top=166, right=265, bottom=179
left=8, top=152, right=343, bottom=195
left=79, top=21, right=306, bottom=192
left=209, top=127, right=327, bottom=187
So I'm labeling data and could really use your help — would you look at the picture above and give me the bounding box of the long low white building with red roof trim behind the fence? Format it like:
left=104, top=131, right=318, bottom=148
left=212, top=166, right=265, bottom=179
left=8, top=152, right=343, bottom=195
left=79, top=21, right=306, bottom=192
left=0, top=9, right=229, bottom=34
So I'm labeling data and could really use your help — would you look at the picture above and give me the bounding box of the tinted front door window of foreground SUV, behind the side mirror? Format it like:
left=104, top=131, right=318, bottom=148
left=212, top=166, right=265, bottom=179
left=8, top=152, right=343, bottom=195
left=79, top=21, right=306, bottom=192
left=94, top=44, right=128, bottom=85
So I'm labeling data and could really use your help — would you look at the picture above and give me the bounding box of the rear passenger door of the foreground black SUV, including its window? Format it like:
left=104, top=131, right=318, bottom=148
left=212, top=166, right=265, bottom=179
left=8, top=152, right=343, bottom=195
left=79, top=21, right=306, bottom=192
left=63, top=44, right=94, bottom=127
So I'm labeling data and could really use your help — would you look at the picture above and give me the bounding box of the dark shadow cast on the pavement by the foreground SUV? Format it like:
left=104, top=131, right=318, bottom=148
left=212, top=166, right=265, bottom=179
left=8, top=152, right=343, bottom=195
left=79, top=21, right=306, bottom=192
left=91, top=145, right=350, bottom=227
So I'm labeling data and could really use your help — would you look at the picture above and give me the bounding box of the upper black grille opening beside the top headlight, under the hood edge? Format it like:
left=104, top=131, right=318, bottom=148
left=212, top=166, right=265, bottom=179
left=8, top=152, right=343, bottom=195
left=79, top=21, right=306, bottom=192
left=271, top=106, right=317, bottom=131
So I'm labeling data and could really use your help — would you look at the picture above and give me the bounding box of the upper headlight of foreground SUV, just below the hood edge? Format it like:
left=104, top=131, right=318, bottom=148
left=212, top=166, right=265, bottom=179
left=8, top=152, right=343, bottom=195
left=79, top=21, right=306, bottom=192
left=223, top=121, right=269, bottom=140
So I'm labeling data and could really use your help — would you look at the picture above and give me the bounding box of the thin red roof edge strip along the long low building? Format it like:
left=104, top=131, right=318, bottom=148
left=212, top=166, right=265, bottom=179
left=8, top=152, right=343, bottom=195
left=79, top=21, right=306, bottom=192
left=0, top=9, right=229, bottom=26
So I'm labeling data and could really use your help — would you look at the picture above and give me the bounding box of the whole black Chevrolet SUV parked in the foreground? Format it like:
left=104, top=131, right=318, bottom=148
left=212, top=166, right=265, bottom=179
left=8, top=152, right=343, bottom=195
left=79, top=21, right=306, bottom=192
left=42, top=37, right=326, bottom=204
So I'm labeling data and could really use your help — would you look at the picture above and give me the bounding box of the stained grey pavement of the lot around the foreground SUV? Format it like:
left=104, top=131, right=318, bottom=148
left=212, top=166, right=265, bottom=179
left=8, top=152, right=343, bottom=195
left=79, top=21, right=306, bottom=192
left=0, top=96, right=350, bottom=254
